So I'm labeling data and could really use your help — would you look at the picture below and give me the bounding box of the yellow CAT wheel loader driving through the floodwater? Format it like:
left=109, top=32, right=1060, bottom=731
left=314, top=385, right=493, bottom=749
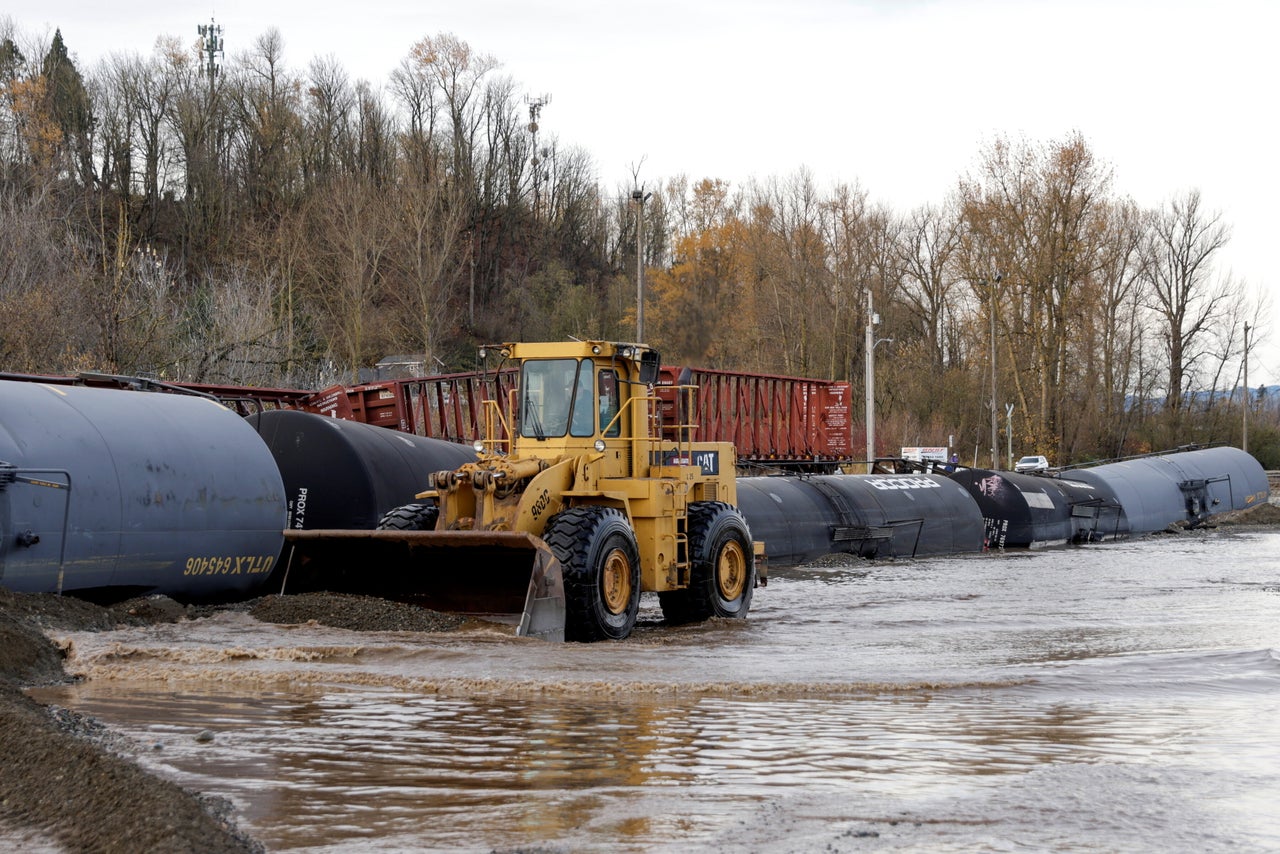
left=285, top=341, right=767, bottom=640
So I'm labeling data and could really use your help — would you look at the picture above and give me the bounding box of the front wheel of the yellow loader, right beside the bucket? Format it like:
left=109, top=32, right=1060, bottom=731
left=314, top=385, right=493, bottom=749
left=543, top=506, right=640, bottom=640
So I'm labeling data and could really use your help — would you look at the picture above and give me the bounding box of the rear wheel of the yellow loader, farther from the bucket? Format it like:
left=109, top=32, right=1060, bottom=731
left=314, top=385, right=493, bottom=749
left=658, top=501, right=755, bottom=624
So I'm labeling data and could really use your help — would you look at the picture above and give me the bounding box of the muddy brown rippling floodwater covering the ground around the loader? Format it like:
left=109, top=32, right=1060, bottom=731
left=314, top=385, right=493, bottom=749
left=36, top=530, right=1280, bottom=851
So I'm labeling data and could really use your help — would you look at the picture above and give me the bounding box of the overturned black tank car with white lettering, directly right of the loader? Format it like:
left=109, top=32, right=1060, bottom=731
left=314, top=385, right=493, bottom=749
left=737, top=475, right=983, bottom=567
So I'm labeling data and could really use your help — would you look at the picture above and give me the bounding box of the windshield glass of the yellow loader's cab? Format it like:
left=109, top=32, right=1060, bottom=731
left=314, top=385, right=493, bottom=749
left=520, top=359, right=595, bottom=439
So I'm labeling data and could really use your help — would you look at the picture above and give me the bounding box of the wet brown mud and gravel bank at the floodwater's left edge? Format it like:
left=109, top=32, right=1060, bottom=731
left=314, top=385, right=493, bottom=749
left=0, top=589, right=462, bottom=853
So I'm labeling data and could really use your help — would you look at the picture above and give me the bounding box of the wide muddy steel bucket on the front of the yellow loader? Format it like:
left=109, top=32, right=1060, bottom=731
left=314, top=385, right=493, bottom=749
left=280, top=530, right=564, bottom=640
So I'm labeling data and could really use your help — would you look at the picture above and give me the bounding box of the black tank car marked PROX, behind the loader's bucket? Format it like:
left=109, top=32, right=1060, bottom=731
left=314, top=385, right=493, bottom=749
left=247, top=410, right=475, bottom=529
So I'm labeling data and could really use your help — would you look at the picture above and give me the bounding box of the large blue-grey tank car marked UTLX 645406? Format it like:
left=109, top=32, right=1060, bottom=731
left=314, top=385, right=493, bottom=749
left=0, top=382, right=284, bottom=602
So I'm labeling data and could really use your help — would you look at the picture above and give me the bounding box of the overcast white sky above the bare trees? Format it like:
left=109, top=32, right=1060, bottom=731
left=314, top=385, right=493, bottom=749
left=10, top=0, right=1280, bottom=385
